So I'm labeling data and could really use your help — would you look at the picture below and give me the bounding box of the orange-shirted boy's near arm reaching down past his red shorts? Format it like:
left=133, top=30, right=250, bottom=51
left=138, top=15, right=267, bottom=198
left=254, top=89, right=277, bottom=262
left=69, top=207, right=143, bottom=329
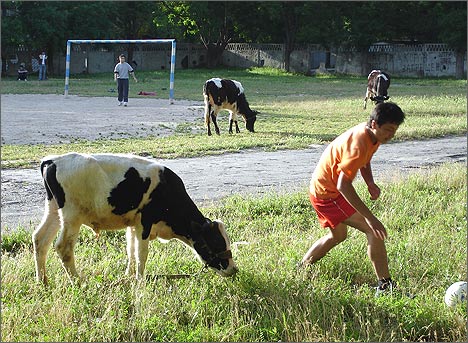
left=337, top=173, right=387, bottom=240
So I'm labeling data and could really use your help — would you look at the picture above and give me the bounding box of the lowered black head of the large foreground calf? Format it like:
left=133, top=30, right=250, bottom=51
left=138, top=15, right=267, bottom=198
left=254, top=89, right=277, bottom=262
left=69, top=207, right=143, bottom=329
left=192, top=219, right=238, bottom=276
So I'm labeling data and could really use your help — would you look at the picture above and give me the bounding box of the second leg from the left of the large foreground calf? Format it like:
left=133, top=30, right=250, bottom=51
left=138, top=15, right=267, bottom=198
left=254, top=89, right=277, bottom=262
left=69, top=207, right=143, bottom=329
left=55, top=214, right=81, bottom=282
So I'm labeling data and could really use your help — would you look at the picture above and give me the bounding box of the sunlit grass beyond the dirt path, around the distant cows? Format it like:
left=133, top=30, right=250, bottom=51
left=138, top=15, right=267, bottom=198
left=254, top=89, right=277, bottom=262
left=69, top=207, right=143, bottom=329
left=2, top=68, right=467, bottom=167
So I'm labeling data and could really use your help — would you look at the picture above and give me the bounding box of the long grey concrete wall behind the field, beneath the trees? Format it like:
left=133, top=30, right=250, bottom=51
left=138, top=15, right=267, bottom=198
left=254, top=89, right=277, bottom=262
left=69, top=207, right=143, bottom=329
left=2, top=43, right=466, bottom=77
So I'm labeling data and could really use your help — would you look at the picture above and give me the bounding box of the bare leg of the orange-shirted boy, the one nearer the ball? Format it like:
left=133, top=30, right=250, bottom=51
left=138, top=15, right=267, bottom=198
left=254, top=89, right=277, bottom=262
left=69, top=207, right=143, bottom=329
left=344, top=212, right=390, bottom=280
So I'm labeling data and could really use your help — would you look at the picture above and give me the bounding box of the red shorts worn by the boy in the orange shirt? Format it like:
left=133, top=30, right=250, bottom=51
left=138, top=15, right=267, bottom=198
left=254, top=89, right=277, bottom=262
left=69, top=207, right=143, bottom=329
left=309, top=193, right=356, bottom=228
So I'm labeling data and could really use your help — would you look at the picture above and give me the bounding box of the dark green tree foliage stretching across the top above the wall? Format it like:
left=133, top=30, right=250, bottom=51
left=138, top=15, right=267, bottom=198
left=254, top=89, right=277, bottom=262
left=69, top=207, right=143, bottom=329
left=1, top=1, right=467, bottom=73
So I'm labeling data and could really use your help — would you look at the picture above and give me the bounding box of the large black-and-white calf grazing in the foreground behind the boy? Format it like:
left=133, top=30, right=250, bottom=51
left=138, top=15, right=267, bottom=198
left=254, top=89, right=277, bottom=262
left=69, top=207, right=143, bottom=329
left=32, top=153, right=237, bottom=283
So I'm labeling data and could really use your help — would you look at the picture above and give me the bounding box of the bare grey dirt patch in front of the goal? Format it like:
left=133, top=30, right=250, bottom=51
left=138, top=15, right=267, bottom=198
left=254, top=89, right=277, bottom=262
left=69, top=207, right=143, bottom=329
left=1, top=94, right=203, bottom=144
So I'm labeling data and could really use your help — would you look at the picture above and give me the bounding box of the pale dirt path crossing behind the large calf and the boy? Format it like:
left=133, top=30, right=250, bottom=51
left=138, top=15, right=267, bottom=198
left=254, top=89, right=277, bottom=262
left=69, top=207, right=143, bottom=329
left=1, top=137, right=467, bottom=230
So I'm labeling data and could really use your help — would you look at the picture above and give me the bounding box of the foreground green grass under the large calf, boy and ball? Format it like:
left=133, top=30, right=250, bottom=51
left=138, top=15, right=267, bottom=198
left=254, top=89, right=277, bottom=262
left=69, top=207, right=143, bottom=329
left=1, top=164, right=467, bottom=342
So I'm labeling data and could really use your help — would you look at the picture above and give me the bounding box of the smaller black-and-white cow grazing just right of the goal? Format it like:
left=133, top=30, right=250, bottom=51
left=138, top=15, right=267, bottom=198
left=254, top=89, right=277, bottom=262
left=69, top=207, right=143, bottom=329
left=203, top=78, right=258, bottom=136
